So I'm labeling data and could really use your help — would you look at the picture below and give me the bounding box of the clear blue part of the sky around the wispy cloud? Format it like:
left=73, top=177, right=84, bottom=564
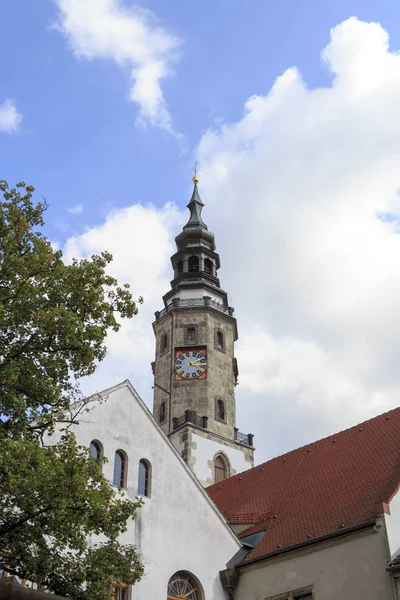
left=0, top=0, right=400, bottom=241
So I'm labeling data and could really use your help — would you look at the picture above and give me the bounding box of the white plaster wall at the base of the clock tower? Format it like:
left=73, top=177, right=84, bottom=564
left=192, top=432, right=251, bottom=486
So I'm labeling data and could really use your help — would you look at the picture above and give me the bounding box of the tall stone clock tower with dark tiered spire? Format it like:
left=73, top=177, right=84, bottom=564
left=153, top=176, right=254, bottom=486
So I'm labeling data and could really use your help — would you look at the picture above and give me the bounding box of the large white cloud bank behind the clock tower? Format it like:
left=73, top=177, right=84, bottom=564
left=64, top=18, right=400, bottom=462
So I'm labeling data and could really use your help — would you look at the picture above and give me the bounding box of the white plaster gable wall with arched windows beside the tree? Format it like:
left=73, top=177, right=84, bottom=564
left=45, top=383, right=240, bottom=600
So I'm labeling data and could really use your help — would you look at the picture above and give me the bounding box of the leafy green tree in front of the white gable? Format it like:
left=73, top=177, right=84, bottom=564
left=0, top=181, right=143, bottom=600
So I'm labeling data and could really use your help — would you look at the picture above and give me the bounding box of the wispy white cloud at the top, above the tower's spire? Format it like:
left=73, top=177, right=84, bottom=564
left=55, top=0, right=180, bottom=132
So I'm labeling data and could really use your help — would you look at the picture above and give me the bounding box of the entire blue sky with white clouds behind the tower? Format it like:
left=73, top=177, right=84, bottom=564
left=0, top=0, right=400, bottom=462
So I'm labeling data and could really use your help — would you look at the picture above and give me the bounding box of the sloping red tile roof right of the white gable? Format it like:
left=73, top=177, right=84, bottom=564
left=207, top=408, right=400, bottom=560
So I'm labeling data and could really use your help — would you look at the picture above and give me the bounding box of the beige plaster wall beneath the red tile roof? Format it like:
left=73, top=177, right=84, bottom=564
left=235, top=528, right=395, bottom=600
